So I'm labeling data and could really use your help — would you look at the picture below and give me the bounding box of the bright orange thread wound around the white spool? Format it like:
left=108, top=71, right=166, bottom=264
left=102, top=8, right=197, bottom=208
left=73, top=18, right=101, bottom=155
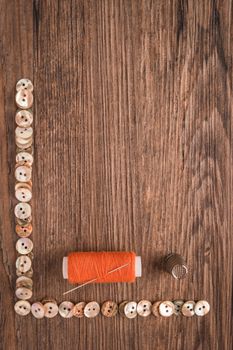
left=68, top=252, right=136, bottom=283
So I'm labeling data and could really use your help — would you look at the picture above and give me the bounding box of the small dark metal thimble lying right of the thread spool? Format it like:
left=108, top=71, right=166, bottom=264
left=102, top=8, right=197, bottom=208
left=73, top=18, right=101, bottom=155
left=164, top=253, right=188, bottom=279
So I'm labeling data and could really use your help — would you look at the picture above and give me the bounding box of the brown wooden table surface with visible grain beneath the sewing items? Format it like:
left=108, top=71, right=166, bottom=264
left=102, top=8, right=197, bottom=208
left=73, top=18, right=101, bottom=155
left=0, top=0, right=233, bottom=350
